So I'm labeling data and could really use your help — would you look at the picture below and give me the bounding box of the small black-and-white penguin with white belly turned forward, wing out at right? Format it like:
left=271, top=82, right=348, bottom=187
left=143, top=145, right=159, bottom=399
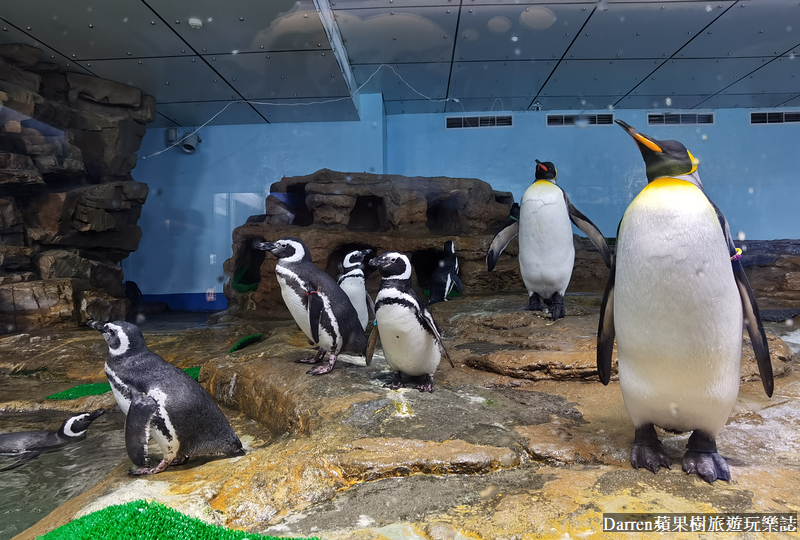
left=369, top=251, right=455, bottom=392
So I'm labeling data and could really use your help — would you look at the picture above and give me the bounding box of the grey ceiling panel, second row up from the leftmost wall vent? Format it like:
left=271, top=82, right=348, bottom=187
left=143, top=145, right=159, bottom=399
left=450, top=60, right=556, bottom=101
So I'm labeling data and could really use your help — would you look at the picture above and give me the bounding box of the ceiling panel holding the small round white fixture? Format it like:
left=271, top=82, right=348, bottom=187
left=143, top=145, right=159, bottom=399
left=148, top=0, right=331, bottom=54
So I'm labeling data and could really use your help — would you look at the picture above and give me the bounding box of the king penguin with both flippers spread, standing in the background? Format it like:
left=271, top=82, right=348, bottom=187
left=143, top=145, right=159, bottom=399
left=486, top=159, right=611, bottom=320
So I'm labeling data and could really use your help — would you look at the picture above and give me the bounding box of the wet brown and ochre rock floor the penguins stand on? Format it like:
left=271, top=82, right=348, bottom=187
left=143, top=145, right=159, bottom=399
left=0, top=295, right=800, bottom=539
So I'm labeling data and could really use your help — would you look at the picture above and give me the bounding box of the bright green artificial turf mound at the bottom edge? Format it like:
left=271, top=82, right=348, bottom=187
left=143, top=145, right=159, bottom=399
left=39, top=500, right=319, bottom=540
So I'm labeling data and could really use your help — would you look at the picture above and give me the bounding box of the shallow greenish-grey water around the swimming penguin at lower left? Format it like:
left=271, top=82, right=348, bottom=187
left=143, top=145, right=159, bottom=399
left=0, top=411, right=128, bottom=540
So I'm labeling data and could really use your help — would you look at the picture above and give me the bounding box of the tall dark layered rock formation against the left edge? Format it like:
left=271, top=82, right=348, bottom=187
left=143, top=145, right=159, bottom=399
left=0, top=45, right=155, bottom=333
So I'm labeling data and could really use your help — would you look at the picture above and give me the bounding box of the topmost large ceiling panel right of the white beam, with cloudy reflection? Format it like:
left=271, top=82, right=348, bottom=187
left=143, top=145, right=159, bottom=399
left=334, top=5, right=458, bottom=64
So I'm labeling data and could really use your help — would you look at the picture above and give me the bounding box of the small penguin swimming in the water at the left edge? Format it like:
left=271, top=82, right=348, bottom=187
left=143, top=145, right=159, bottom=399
left=0, top=409, right=105, bottom=472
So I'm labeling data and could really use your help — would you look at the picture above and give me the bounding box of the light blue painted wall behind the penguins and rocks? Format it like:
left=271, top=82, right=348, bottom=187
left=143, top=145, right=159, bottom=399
left=123, top=95, right=800, bottom=309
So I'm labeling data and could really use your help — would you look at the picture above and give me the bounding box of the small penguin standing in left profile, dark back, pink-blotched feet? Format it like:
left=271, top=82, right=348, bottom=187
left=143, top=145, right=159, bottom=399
left=254, top=236, right=367, bottom=375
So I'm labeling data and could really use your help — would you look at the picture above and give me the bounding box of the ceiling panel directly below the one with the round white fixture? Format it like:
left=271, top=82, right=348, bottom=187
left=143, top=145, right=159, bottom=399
left=209, top=51, right=350, bottom=99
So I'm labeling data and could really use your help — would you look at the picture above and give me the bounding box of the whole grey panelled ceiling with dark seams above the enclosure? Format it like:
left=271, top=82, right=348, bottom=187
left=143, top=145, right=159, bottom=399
left=0, top=0, right=800, bottom=127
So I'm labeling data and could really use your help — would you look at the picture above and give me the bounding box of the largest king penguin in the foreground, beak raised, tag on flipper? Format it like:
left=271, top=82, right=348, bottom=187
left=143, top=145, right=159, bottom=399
left=597, top=120, right=773, bottom=482
